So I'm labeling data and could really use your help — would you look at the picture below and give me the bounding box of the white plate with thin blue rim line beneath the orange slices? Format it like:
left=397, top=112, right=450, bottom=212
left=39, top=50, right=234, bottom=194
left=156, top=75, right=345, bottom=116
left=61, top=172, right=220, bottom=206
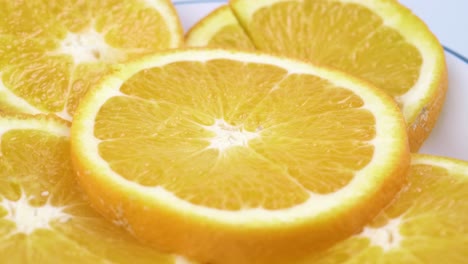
left=173, top=0, right=468, bottom=160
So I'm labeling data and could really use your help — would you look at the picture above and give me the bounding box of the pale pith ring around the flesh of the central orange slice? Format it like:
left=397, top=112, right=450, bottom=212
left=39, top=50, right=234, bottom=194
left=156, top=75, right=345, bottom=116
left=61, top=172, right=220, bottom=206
left=73, top=50, right=405, bottom=226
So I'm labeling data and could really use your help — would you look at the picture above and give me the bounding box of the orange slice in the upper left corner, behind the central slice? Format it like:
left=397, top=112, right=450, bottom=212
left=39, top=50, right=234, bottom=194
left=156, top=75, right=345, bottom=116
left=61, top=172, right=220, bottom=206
left=0, top=0, right=183, bottom=120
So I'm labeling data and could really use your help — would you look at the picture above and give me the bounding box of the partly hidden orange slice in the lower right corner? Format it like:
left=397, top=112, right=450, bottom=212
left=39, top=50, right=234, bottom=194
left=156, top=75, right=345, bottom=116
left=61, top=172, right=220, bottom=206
left=298, top=154, right=468, bottom=264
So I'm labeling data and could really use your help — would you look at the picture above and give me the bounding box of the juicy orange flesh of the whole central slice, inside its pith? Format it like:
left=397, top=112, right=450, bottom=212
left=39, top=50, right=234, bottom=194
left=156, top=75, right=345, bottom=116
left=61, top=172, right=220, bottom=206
left=94, top=60, right=375, bottom=210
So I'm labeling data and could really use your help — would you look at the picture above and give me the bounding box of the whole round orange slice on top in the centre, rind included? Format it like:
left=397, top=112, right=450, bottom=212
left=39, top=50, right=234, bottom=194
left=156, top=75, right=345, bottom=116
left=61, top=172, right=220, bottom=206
left=72, top=50, right=409, bottom=263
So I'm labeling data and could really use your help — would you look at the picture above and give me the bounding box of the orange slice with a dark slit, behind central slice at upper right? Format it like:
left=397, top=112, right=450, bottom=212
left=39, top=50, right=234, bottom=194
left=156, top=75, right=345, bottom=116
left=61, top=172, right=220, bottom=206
left=187, top=0, right=447, bottom=151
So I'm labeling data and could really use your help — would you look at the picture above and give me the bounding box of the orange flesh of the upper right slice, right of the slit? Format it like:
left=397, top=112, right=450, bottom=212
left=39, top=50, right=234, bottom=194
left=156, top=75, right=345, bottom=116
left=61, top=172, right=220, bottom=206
left=241, top=0, right=422, bottom=96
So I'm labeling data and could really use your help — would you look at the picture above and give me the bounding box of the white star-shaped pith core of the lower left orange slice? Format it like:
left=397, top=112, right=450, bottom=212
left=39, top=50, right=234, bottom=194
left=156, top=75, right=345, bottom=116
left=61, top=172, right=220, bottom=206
left=0, top=192, right=72, bottom=235
